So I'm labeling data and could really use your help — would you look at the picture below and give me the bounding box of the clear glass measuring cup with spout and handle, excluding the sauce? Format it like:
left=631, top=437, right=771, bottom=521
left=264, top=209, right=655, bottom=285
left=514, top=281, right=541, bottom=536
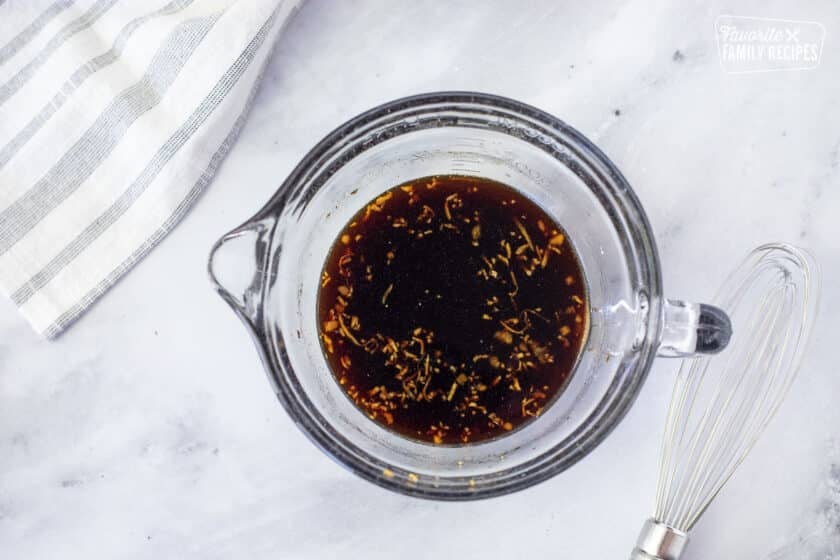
left=209, top=92, right=731, bottom=500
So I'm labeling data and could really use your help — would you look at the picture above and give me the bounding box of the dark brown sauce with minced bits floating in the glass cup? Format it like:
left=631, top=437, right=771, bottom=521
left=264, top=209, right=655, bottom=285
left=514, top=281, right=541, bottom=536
left=318, top=176, right=588, bottom=444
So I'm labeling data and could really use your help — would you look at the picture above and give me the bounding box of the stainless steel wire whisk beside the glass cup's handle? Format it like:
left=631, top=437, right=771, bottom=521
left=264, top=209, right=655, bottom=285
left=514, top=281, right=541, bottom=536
left=631, top=244, right=819, bottom=560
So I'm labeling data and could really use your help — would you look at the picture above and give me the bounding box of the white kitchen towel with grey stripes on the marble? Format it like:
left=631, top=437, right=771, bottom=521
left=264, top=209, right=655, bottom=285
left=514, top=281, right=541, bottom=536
left=0, top=0, right=300, bottom=338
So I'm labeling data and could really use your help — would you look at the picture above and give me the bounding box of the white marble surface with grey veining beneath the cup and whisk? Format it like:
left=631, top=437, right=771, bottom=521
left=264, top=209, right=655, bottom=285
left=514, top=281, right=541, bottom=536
left=0, top=0, right=840, bottom=560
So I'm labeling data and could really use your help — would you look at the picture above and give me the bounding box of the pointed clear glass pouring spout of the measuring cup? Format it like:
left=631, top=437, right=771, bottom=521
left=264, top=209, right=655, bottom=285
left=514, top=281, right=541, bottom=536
left=207, top=218, right=275, bottom=330
